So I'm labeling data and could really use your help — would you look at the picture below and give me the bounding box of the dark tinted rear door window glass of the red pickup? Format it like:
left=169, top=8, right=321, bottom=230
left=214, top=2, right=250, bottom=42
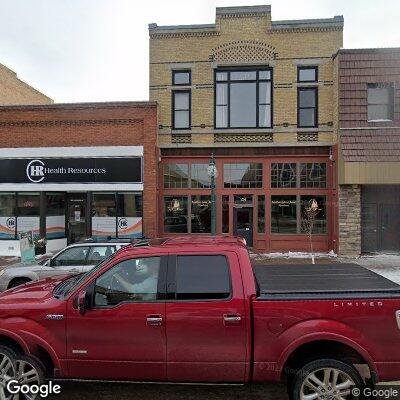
left=176, top=255, right=231, bottom=300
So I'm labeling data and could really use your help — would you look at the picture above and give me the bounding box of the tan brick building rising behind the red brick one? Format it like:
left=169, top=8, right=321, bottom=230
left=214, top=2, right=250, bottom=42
left=0, top=64, right=53, bottom=106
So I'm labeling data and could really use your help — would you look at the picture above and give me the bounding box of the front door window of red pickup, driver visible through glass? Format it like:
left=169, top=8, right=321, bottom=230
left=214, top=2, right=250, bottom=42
left=94, top=257, right=160, bottom=306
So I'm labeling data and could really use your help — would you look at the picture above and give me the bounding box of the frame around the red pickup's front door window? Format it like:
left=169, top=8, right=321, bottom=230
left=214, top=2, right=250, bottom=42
left=88, top=253, right=168, bottom=310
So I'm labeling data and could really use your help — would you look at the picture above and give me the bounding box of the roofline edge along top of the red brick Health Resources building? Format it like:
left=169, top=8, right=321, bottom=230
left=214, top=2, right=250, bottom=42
left=0, top=101, right=157, bottom=112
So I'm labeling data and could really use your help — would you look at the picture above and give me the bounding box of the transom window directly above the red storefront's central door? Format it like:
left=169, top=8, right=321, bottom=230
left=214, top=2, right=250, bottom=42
left=224, top=163, right=263, bottom=188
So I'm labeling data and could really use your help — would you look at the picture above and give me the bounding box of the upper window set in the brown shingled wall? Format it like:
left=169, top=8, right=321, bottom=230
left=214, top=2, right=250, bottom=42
left=368, top=83, right=394, bottom=121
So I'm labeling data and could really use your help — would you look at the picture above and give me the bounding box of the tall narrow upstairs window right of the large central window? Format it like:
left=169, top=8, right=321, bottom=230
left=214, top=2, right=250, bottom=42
left=297, top=87, right=318, bottom=128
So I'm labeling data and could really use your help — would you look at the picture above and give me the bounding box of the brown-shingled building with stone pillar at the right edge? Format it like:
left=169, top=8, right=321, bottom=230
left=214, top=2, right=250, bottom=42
left=336, top=48, right=400, bottom=254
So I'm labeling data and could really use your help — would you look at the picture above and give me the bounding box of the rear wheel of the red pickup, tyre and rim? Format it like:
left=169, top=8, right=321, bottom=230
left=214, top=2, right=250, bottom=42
left=289, top=358, right=365, bottom=400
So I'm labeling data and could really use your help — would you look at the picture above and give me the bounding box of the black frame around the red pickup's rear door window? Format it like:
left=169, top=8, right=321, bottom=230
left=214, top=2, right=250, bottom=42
left=166, top=252, right=233, bottom=303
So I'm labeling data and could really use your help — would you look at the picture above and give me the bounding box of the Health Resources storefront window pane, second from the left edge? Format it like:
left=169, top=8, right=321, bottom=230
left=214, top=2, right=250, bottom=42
left=17, top=192, right=40, bottom=236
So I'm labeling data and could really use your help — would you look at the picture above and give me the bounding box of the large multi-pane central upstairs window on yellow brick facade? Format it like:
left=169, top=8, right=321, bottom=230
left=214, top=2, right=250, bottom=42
left=215, top=69, right=272, bottom=128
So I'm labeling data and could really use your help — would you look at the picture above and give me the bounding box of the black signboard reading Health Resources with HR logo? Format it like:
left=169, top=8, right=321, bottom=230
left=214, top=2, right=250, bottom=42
left=0, top=157, right=142, bottom=183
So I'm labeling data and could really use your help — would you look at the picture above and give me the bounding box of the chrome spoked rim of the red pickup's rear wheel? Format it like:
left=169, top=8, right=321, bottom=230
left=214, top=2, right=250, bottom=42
left=300, top=368, right=355, bottom=400
